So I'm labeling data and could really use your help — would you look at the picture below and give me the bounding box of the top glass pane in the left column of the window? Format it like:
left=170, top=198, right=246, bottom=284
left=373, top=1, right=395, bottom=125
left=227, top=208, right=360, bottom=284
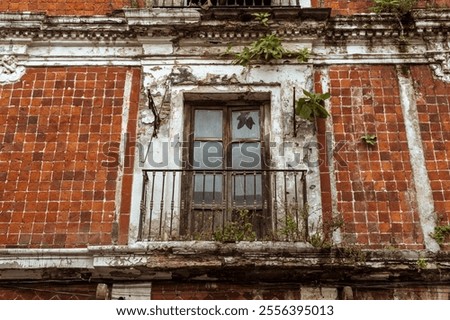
left=194, top=110, right=223, bottom=139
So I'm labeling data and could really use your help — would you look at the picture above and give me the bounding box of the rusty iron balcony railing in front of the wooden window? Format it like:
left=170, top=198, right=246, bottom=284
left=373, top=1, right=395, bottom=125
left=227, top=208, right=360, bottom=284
left=139, top=169, right=308, bottom=241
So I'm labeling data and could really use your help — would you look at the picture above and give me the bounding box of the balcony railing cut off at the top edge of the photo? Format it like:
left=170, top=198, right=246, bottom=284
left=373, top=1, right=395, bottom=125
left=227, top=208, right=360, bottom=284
left=148, top=0, right=304, bottom=7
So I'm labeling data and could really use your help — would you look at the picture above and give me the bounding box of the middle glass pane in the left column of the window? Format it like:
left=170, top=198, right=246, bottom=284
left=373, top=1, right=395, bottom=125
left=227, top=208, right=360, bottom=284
left=192, top=141, right=223, bottom=169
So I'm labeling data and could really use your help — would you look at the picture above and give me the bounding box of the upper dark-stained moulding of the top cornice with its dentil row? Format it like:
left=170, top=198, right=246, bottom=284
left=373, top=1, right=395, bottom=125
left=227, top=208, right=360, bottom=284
left=0, top=8, right=450, bottom=40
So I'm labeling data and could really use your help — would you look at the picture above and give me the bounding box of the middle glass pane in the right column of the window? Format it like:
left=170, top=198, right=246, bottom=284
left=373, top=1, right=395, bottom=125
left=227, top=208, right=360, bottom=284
left=231, top=142, right=261, bottom=169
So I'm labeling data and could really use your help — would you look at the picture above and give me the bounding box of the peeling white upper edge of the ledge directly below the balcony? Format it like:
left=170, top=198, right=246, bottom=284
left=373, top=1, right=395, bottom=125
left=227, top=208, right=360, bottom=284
left=0, top=241, right=450, bottom=269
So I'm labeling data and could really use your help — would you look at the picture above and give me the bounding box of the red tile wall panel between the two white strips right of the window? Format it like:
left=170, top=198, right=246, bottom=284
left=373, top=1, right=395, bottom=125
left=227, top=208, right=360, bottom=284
left=329, top=66, right=423, bottom=249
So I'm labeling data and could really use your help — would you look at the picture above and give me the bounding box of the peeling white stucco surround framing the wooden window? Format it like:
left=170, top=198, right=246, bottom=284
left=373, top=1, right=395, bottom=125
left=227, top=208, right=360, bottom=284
left=129, top=61, right=321, bottom=243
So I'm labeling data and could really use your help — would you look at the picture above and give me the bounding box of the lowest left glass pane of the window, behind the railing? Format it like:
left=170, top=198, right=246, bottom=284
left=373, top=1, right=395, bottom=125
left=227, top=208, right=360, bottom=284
left=194, top=172, right=223, bottom=205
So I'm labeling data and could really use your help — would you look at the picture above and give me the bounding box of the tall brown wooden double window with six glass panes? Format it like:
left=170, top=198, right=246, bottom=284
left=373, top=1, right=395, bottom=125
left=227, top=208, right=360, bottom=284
left=181, top=100, right=270, bottom=238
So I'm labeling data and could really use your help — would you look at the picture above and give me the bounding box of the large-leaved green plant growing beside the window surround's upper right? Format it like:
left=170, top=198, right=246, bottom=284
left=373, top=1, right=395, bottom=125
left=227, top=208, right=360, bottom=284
left=295, top=90, right=330, bottom=121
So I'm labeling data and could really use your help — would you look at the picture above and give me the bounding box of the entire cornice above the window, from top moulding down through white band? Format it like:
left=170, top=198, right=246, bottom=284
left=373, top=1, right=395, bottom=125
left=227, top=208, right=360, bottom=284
left=0, top=8, right=450, bottom=66
